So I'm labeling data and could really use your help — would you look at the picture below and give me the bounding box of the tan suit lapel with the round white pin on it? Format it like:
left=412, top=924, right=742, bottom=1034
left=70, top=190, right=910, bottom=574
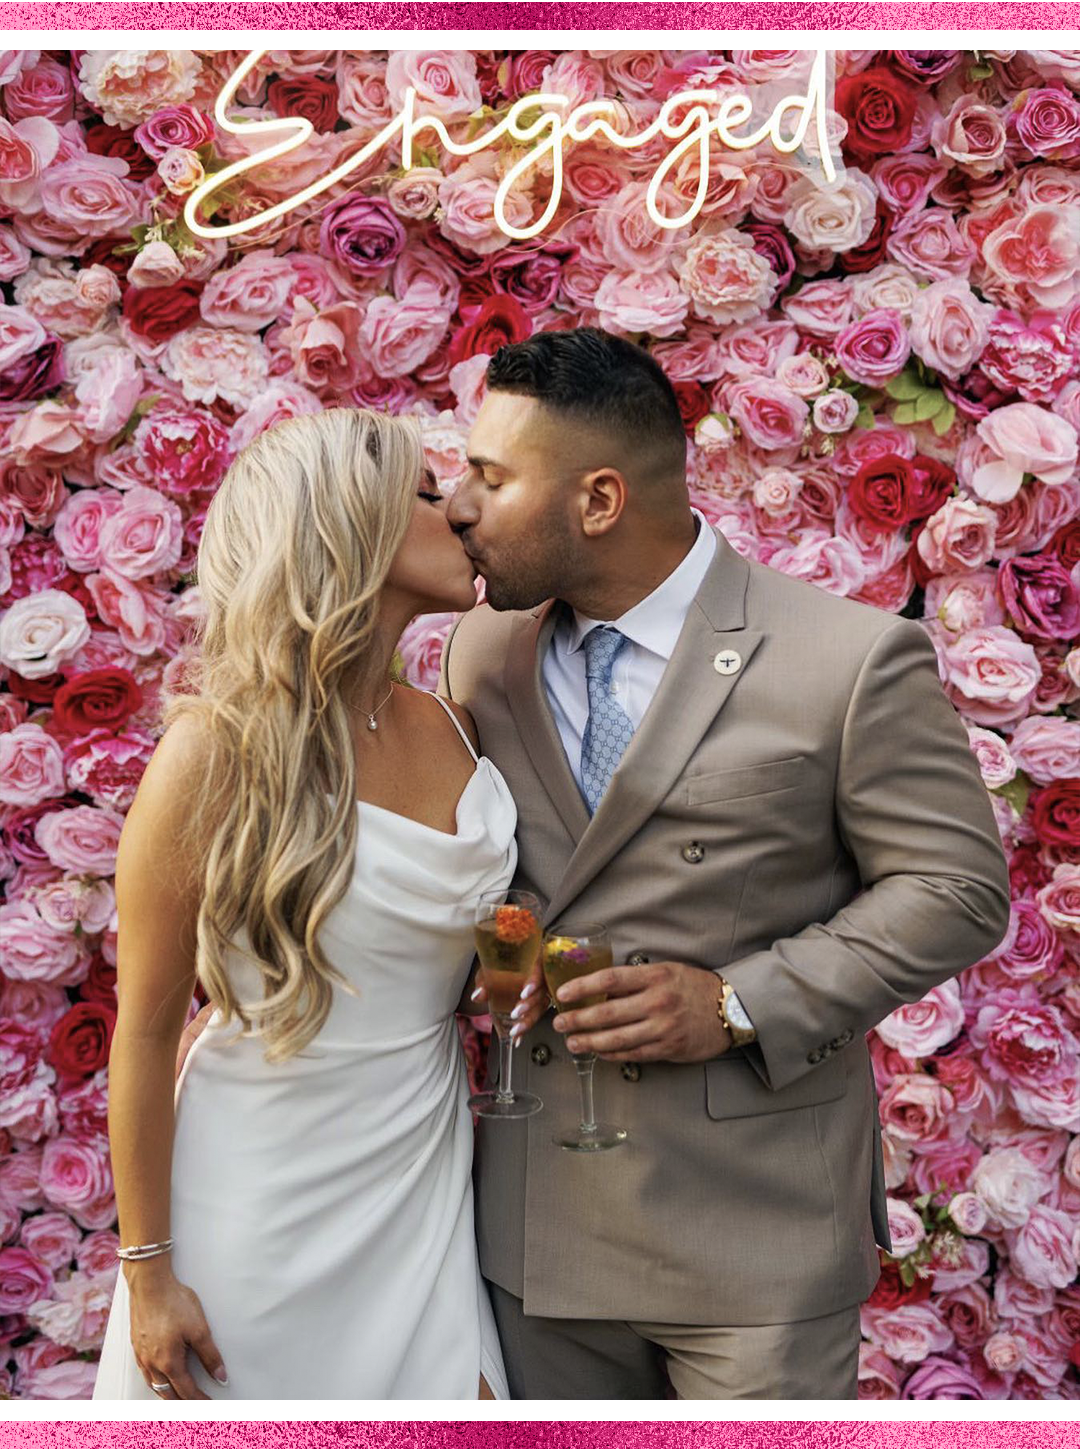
left=542, top=529, right=764, bottom=922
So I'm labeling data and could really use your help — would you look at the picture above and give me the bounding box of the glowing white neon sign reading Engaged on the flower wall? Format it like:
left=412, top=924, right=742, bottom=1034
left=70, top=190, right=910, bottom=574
left=184, top=49, right=836, bottom=241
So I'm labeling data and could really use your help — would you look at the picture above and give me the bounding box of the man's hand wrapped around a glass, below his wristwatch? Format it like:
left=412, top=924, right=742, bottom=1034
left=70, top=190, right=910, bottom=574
left=552, top=961, right=731, bottom=1063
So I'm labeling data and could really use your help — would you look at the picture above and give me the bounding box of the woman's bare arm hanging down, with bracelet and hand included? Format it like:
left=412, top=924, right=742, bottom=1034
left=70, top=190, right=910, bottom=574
left=109, top=719, right=225, bottom=1399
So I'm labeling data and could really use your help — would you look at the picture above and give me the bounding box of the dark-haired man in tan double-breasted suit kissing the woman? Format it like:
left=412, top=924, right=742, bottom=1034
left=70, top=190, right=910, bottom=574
left=439, top=328, right=1009, bottom=1399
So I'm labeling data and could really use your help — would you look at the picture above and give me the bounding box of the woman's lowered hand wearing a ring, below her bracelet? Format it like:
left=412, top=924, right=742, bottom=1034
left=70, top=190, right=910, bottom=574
left=125, top=1254, right=228, bottom=1399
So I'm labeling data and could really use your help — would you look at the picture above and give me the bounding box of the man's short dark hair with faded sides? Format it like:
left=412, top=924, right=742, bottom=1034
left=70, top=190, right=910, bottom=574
left=487, top=328, right=686, bottom=461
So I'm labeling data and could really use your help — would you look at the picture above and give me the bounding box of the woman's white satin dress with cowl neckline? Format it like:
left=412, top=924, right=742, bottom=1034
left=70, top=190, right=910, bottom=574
left=94, top=696, right=518, bottom=1399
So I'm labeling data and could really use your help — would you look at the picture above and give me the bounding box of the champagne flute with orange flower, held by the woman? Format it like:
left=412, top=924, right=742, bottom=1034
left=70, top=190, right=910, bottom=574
left=468, top=892, right=544, bottom=1118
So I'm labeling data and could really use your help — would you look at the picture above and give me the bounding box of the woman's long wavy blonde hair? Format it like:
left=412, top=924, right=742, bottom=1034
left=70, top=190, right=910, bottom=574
left=164, top=407, right=423, bottom=1061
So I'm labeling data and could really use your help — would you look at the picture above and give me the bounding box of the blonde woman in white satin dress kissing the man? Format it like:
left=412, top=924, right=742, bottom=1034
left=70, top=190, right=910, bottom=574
left=94, top=407, right=544, bottom=1399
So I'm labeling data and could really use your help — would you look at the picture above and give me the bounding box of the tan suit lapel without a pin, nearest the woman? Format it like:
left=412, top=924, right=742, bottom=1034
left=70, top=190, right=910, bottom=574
left=503, top=600, right=589, bottom=844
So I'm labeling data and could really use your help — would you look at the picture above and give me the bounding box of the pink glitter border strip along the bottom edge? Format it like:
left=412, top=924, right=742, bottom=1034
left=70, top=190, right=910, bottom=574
left=0, top=1420, right=1076, bottom=1450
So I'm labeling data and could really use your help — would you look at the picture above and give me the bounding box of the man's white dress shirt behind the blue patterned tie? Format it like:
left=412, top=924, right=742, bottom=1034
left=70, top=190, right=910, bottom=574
left=542, top=509, right=749, bottom=1016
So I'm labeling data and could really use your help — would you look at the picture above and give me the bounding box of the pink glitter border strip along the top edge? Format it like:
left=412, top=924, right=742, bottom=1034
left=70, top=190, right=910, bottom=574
left=3, top=0, right=1077, bottom=32
